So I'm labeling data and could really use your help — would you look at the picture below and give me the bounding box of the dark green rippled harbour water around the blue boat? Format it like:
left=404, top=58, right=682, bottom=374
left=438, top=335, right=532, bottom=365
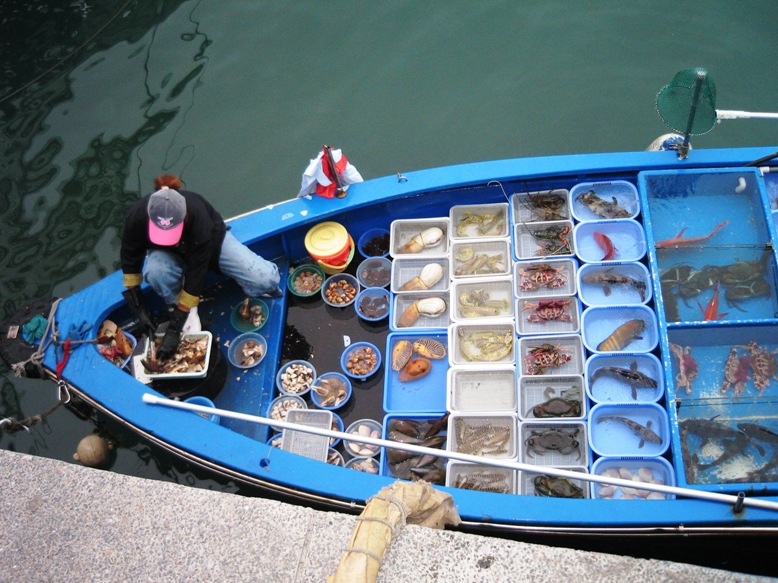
left=0, top=0, right=778, bottom=572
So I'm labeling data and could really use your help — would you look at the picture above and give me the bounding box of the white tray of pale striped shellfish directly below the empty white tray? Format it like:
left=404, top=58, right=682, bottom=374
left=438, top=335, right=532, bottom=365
left=446, top=413, right=517, bottom=459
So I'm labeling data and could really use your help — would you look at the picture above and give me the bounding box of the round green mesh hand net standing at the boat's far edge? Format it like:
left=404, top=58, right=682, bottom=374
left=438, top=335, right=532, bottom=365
left=656, top=67, right=716, bottom=136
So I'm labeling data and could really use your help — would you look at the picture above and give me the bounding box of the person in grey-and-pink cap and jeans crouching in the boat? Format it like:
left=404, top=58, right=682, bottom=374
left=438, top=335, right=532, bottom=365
left=121, top=175, right=282, bottom=360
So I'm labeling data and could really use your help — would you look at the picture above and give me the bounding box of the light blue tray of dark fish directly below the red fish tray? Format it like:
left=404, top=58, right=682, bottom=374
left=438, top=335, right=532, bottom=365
left=577, top=261, right=652, bottom=306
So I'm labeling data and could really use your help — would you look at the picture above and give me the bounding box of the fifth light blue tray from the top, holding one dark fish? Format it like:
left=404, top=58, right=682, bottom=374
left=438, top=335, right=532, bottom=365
left=586, top=353, right=665, bottom=403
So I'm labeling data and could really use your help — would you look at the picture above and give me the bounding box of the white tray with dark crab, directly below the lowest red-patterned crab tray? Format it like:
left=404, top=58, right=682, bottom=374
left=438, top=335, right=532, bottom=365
left=519, top=375, right=586, bottom=421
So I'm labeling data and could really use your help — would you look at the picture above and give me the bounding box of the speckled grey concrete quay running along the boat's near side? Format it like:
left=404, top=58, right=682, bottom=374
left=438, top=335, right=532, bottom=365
left=0, top=450, right=775, bottom=583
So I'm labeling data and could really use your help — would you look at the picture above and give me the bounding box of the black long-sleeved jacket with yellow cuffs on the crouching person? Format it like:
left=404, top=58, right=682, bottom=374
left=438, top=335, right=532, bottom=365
left=121, top=190, right=227, bottom=307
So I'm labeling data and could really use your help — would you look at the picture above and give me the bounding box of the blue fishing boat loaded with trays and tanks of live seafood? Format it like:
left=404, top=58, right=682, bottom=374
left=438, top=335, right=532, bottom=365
left=4, top=68, right=778, bottom=534
